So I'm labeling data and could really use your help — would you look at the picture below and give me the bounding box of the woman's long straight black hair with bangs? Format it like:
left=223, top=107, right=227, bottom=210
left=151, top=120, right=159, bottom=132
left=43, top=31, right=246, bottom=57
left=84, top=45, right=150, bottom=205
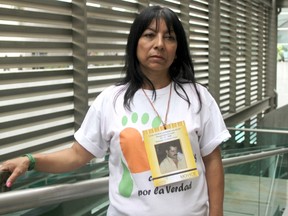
left=117, top=6, right=201, bottom=110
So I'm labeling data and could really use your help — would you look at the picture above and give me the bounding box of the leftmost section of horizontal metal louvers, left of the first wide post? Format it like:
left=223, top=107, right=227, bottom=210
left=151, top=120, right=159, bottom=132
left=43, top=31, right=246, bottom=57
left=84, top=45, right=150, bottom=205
left=0, top=0, right=74, bottom=160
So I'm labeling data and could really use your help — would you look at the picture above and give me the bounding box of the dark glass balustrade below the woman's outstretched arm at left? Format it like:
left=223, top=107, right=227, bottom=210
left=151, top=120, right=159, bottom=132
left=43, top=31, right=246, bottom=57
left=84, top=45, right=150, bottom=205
left=0, top=155, right=109, bottom=216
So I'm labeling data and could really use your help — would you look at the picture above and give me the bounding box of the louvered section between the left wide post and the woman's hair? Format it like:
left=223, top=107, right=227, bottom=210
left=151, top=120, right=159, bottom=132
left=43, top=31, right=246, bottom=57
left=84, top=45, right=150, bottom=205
left=87, top=0, right=138, bottom=103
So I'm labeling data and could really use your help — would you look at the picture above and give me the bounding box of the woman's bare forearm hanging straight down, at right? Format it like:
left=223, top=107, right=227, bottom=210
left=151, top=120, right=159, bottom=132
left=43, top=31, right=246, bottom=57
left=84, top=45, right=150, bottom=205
left=203, top=148, right=224, bottom=216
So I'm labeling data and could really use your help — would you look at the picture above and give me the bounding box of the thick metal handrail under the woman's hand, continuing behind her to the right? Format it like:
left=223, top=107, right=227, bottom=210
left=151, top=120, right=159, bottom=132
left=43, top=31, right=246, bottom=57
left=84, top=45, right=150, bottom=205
left=0, top=148, right=288, bottom=214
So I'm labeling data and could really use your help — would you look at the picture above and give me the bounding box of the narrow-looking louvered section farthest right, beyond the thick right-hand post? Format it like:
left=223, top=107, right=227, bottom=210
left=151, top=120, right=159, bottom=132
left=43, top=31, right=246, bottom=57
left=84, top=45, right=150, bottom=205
left=220, top=0, right=268, bottom=113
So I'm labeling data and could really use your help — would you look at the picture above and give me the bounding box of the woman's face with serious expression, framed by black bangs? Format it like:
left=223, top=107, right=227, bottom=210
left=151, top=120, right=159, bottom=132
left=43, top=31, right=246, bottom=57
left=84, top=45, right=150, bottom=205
left=137, top=19, right=177, bottom=77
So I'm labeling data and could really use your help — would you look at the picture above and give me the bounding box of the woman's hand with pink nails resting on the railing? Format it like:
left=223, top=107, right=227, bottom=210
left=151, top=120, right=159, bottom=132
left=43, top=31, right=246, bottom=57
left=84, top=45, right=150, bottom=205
left=0, top=157, right=30, bottom=188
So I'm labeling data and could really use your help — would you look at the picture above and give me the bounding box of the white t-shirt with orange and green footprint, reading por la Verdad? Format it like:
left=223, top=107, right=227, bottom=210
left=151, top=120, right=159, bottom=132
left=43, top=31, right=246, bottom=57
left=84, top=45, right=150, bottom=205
left=75, top=84, right=230, bottom=216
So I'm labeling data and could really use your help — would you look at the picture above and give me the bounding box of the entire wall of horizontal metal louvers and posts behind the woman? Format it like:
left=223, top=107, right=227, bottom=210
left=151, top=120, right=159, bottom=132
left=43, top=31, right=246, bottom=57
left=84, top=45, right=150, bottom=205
left=0, top=0, right=273, bottom=160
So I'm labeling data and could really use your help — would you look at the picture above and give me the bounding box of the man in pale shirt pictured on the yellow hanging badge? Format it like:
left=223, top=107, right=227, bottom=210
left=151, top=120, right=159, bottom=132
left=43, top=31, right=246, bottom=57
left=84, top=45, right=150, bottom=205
left=160, top=140, right=187, bottom=174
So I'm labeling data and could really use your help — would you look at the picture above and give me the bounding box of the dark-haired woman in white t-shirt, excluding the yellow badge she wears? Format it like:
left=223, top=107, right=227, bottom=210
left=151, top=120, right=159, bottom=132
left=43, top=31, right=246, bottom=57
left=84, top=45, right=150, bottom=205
left=1, top=6, right=230, bottom=216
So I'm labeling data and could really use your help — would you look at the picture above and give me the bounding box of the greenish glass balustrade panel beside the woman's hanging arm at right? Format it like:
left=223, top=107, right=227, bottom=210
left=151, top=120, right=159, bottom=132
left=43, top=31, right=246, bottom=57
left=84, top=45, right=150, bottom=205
left=222, top=128, right=288, bottom=216
